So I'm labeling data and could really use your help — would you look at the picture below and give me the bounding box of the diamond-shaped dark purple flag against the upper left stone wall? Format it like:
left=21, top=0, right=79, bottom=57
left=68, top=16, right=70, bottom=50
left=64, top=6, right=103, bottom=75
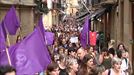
left=3, top=6, right=20, bottom=35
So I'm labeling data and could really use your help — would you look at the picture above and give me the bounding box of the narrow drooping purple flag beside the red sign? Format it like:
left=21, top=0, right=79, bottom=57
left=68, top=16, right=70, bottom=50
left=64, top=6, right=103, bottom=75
left=80, top=16, right=91, bottom=48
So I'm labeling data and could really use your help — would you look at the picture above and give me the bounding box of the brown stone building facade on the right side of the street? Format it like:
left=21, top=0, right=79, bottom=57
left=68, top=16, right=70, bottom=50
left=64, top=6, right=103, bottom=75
left=90, top=0, right=134, bottom=72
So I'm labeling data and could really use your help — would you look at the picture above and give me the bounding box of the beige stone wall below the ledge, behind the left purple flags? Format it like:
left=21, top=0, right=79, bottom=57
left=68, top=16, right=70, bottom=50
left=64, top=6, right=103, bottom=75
left=0, top=4, right=37, bottom=45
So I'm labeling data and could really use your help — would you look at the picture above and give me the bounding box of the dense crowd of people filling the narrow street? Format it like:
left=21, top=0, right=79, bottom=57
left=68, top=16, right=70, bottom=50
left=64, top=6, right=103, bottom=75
left=0, top=20, right=132, bottom=75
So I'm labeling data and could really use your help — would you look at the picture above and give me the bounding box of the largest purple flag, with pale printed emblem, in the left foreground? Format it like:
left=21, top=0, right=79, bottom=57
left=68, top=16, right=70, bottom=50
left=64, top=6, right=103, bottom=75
left=3, top=28, right=51, bottom=75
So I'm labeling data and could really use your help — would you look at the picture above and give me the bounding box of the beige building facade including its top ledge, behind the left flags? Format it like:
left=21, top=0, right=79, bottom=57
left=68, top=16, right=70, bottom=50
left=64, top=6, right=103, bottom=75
left=0, top=0, right=37, bottom=44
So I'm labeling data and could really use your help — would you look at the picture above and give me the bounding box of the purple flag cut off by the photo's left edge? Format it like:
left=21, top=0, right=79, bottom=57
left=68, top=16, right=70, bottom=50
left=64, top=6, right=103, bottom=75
left=0, top=24, right=6, bottom=52
